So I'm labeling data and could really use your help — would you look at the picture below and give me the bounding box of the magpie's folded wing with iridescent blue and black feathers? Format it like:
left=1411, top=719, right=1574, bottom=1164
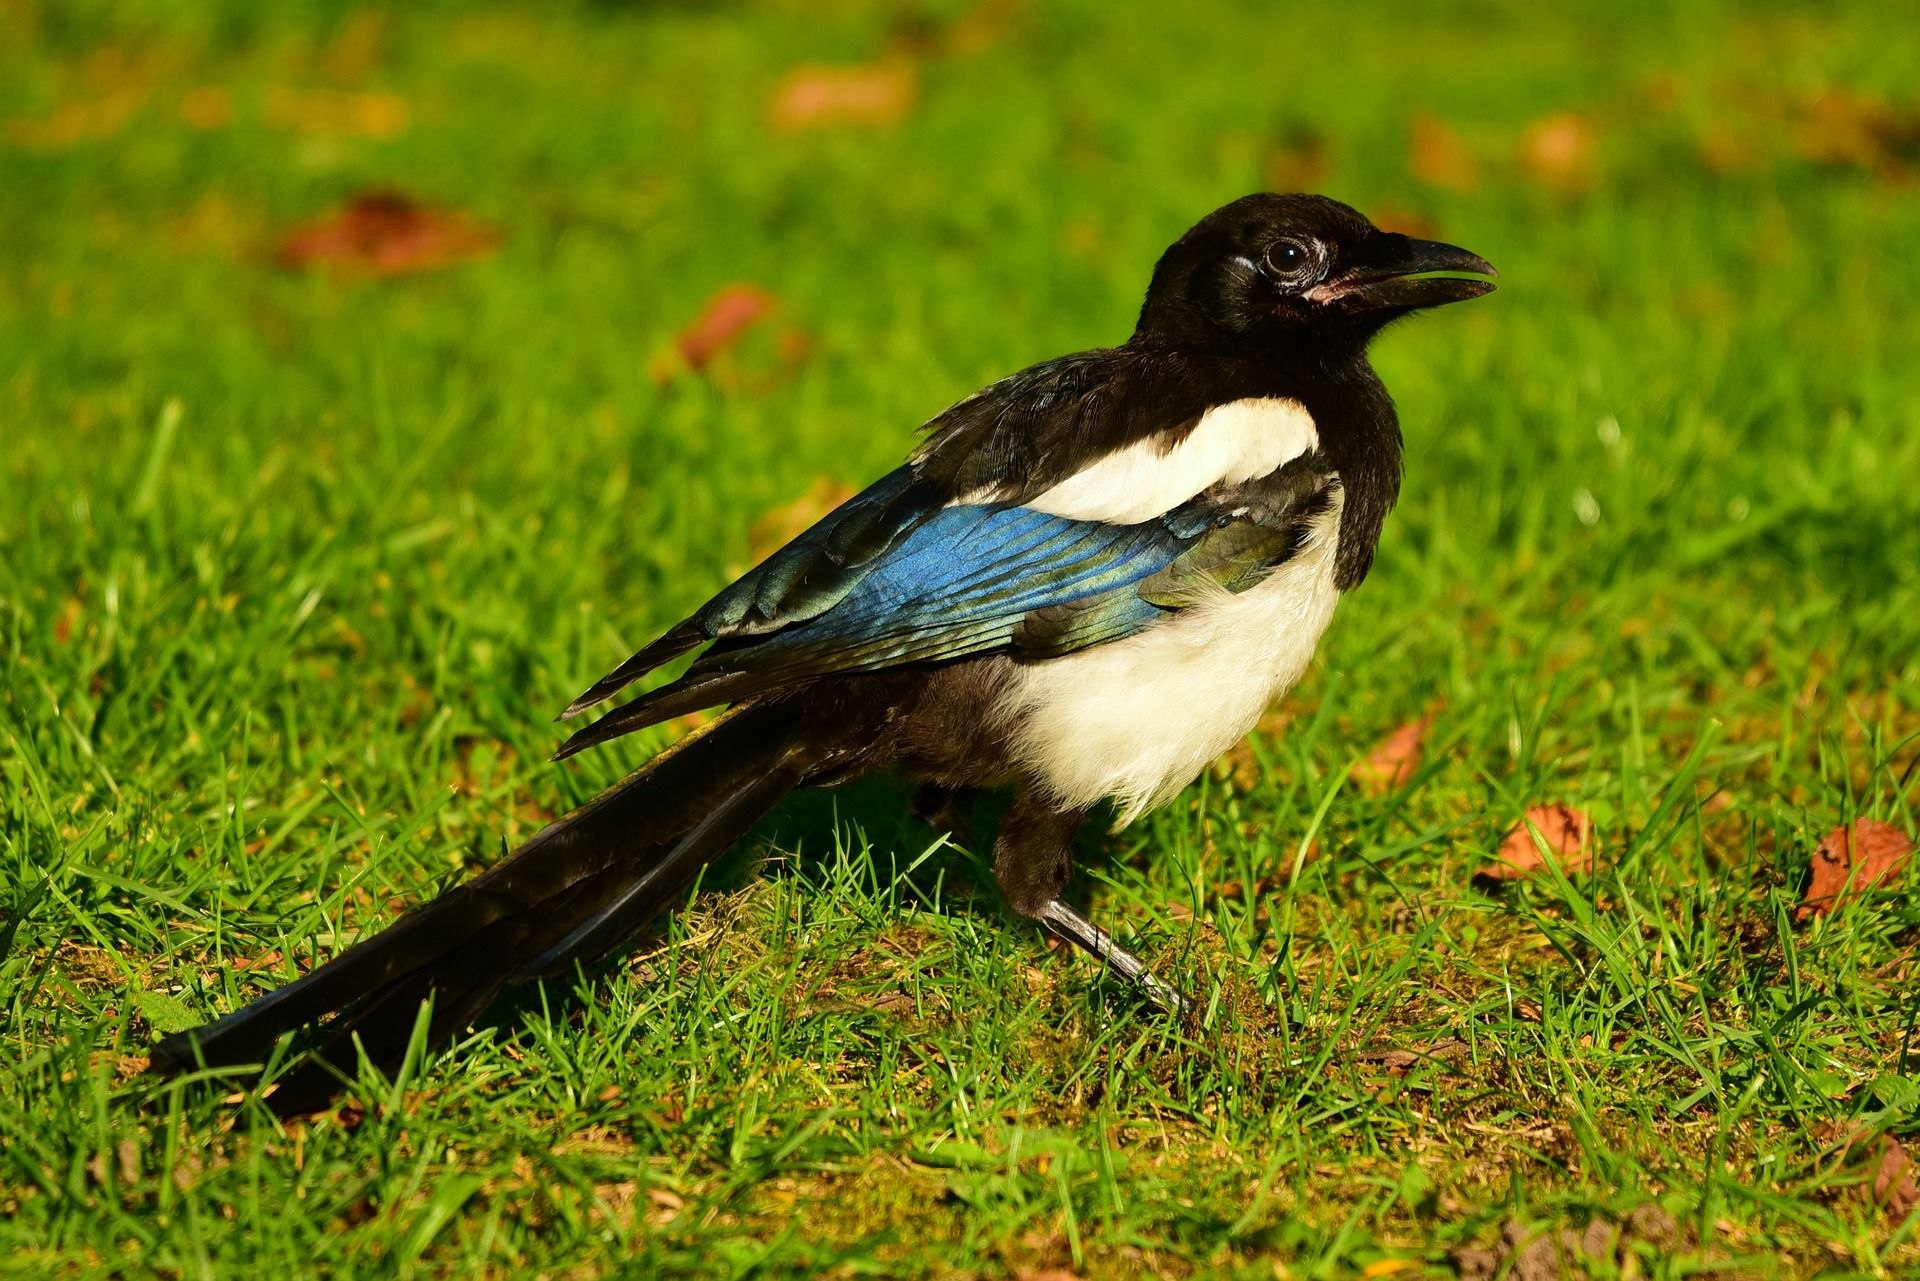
left=557, top=459, right=1338, bottom=757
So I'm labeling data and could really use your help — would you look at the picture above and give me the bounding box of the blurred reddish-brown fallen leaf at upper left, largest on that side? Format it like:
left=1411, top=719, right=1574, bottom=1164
left=276, top=192, right=499, bottom=277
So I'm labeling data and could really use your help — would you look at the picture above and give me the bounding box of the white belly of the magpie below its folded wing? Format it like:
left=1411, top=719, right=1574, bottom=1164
left=1000, top=494, right=1340, bottom=826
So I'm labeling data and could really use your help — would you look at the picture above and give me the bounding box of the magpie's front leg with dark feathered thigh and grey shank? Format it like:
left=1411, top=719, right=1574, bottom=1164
left=993, top=791, right=1190, bottom=1014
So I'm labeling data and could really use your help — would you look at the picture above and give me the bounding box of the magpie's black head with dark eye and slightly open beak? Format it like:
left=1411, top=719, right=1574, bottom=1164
left=1135, top=194, right=1496, bottom=355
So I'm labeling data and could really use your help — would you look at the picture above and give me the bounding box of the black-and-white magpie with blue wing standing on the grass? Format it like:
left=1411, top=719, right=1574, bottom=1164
left=154, top=194, right=1496, bottom=1114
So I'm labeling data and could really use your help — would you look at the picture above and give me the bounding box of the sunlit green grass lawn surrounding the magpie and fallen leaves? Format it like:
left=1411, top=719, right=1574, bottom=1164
left=0, top=0, right=1920, bottom=1279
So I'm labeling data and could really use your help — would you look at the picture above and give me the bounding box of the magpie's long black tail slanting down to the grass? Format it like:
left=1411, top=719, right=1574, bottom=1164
left=152, top=699, right=837, bottom=1116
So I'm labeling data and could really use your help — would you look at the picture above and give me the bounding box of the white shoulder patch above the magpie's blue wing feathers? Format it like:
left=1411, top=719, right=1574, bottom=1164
left=960, top=398, right=1319, bottom=524
